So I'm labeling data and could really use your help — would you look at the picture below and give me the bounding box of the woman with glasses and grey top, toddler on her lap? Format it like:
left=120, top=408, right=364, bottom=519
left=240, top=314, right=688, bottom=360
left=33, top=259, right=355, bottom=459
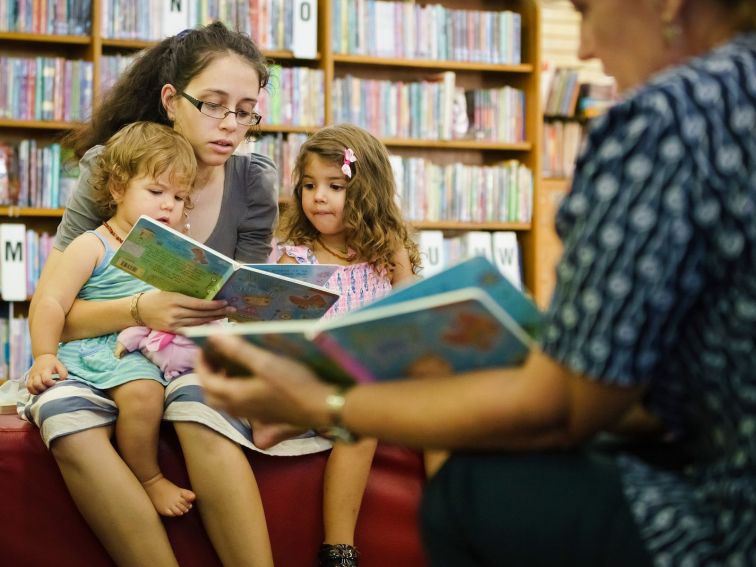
left=25, top=22, right=329, bottom=567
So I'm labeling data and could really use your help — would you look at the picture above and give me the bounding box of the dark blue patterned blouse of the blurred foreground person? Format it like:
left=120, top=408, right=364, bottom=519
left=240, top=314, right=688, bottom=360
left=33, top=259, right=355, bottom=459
left=543, top=32, right=756, bottom=566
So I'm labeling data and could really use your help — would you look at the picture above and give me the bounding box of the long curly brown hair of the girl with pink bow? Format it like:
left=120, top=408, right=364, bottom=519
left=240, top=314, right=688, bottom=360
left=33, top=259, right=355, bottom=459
left=279, top=124, right=420, bottom=273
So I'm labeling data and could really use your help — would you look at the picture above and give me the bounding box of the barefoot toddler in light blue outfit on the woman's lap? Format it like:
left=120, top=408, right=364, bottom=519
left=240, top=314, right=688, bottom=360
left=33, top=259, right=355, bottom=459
left=27, top=122, right=197, bottom=516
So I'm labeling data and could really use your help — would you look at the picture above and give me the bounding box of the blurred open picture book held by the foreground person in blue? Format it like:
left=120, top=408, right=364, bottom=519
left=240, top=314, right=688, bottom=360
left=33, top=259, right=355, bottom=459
left=181, top=257, right=542, bottom=384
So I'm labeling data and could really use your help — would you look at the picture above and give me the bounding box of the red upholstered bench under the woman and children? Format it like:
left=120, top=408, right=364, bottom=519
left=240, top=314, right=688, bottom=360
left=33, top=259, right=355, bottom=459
left=0, top=415, right=426, bottom=567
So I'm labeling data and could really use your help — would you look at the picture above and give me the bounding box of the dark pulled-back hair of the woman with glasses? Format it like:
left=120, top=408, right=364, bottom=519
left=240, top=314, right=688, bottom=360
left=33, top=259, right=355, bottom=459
left=63, top=22, right=270, bottom=158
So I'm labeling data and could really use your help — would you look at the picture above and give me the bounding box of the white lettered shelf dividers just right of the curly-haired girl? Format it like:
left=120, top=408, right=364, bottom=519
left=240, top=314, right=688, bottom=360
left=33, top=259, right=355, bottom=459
left=415, top=230, right=522, bottom=290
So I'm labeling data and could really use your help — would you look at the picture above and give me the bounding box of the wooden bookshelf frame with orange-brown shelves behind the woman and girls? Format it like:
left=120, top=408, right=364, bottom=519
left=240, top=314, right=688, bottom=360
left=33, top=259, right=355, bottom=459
left=0, top=0, right=553, bottom=380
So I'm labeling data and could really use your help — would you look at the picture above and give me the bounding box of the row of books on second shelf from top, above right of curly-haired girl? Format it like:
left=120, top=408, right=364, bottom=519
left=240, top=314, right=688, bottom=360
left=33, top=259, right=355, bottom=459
left=333, top=71, right=525, bottom=143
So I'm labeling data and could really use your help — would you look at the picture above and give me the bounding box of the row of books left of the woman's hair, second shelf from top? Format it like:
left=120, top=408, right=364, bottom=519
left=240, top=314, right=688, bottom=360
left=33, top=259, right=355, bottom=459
left=0, top=56, right=94, bottom=122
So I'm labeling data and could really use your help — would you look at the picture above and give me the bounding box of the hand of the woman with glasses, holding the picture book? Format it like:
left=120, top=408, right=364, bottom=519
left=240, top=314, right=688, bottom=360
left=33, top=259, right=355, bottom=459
left=137, top=290, right=235, bottom=333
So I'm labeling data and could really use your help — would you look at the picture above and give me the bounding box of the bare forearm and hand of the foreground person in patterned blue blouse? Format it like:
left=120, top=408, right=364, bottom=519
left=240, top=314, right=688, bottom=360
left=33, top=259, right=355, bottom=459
left=198, top=337, right=643, bottom=449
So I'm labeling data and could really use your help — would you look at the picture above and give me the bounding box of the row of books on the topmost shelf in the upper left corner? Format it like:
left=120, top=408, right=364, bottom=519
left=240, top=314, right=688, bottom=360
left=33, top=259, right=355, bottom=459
left=0, top=0, right=92, bottom=35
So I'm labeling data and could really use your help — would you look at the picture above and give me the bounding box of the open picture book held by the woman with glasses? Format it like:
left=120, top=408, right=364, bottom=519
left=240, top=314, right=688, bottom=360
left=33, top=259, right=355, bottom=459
left=111, top=216, right=339, bottom=321
